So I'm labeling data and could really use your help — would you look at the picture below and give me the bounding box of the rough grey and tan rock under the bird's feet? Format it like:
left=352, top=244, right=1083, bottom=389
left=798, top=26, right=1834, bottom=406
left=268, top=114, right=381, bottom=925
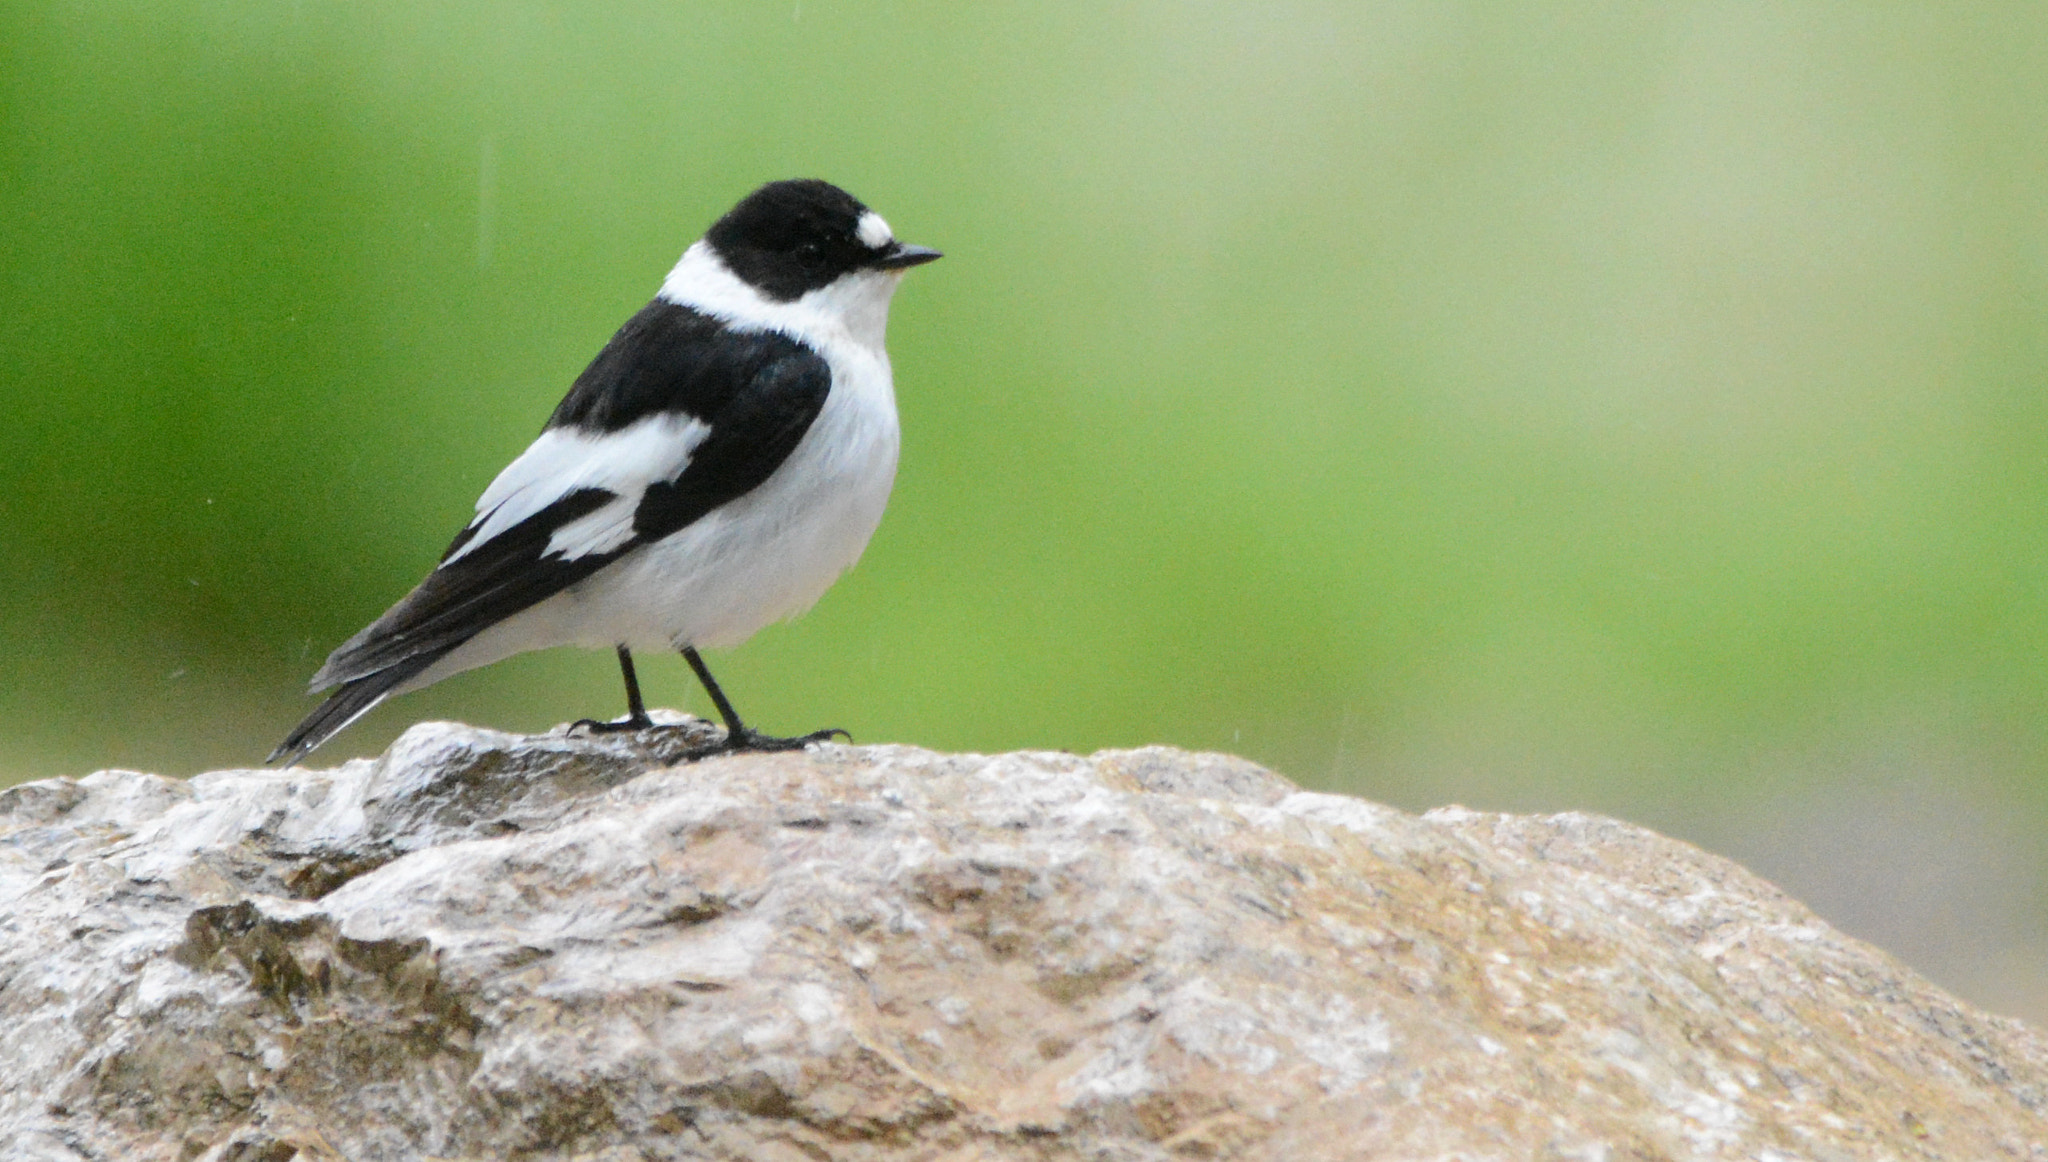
left=0, top=723, right=2048, bottom=1162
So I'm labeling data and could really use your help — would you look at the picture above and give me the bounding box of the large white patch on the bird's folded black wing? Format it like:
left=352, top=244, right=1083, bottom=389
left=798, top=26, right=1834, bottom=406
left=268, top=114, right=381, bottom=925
left=442, top=412, right=711, bottom=564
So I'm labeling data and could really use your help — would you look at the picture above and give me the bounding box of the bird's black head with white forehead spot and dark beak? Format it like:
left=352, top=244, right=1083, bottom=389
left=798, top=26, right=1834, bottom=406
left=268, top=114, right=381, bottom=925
left=705, top=178, right=938, bottom=303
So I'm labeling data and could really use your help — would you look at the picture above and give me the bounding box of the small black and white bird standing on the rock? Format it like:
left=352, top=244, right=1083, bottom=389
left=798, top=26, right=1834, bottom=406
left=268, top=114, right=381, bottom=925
left=268, top=178, right=940, bottom=766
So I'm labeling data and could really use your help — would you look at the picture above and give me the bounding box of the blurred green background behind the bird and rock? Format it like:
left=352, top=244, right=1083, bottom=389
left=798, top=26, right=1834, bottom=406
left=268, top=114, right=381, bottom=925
left=0, top=0, right=2048, bottom=1019
